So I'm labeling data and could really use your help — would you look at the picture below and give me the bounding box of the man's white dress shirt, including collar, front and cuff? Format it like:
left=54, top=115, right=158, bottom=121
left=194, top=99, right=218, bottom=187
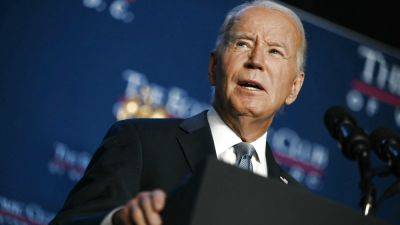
left=100, top=108, right=268, bottom=225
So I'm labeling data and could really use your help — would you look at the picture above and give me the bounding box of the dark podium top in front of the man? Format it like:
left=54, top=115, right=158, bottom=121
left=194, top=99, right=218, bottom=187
left=163, top=158, right=388, bottom=225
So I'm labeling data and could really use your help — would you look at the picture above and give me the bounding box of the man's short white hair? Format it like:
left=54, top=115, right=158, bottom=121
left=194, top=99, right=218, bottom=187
left=215, top=0, right=307, bottom=71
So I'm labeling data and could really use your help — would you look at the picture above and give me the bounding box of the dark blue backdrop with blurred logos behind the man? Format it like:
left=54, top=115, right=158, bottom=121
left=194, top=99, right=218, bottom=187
left=0, top=0, right=400, bottom=224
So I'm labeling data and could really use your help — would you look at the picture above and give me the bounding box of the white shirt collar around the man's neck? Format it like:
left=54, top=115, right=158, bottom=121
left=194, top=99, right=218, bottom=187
left=207, top=108, right=267, bottom=161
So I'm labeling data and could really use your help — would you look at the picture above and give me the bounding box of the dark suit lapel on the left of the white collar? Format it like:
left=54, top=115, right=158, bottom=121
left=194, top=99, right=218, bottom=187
left=177, top=111, right=216, bottom=172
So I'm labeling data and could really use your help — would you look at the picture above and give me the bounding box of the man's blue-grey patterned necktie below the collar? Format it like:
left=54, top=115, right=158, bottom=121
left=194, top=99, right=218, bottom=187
left=233, top=142, right=257, bottom=172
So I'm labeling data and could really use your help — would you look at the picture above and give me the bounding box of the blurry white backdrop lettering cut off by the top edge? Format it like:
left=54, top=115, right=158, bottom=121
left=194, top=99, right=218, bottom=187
left=82, top=0, right=135, bottom=23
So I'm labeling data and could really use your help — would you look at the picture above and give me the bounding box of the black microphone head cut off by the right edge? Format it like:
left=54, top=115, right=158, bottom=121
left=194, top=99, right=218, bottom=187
left=370, top=127, right=400, bottom=178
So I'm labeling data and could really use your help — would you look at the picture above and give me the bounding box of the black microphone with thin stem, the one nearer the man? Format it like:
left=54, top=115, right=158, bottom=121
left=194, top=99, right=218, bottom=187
left=324, top=106, right=376, bottom=215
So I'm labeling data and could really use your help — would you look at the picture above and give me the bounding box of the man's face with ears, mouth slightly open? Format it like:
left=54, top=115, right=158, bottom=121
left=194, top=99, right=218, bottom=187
left=209, top=7, right=304, bottom=118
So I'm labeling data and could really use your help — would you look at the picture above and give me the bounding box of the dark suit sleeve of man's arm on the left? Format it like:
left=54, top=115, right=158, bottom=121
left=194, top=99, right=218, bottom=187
left=50, top=120, right=142, bottom=225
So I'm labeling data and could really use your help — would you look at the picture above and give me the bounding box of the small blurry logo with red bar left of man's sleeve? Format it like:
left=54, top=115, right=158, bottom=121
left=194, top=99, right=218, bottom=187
left=48, top=142, right=91, bottom=181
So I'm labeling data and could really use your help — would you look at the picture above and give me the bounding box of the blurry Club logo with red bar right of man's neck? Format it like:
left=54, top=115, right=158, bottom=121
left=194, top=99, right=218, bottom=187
left=268, top=127, right=329, bottom=190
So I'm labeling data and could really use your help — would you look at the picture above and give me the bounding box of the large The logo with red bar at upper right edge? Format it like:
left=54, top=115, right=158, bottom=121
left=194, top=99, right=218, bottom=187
left=346, top=46, right=400, bottom=127
